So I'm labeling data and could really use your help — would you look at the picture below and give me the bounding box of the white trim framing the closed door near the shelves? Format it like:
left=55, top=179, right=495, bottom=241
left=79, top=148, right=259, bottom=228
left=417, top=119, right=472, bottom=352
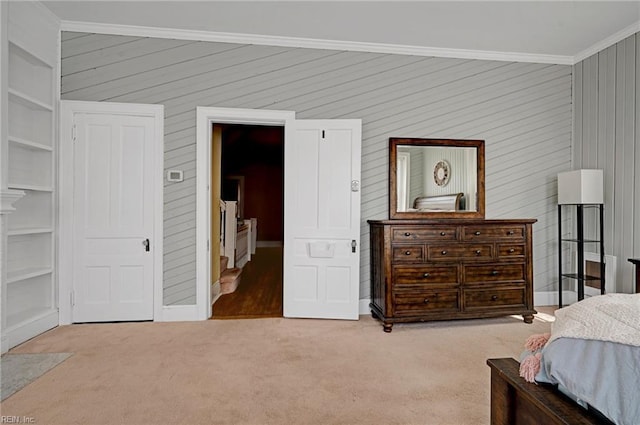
left=57, top=100, right=164, bottom=325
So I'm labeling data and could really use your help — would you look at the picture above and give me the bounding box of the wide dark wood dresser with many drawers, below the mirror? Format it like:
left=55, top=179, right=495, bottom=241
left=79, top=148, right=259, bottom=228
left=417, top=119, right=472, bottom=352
left=368, top=219, right=536, bottom=332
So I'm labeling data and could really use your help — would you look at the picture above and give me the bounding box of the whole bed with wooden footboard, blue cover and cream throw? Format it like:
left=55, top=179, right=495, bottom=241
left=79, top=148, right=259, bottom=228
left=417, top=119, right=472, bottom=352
left=487, top=294, right=640, bottom=425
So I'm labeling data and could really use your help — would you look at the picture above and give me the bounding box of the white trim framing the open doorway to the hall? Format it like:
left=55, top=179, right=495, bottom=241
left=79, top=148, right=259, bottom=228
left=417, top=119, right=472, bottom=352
left=196, top=106, right=296, bottom=320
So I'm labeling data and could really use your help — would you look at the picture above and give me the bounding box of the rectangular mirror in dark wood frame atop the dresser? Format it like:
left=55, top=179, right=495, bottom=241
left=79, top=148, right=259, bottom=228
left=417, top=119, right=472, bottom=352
left=389, top=138, right=484, bottom=219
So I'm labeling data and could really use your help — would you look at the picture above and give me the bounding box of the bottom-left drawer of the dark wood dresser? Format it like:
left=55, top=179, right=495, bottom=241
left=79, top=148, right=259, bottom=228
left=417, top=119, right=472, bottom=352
left=394, top=290, right=460, bottom=316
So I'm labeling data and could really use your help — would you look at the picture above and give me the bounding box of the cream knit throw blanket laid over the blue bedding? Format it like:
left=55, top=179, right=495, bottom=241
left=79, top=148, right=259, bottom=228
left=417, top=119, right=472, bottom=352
left=549, top=294, right=640, bottom=346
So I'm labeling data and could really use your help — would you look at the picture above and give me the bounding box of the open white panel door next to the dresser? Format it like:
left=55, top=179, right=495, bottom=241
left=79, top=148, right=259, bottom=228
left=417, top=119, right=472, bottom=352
left=283, top=120, right=362, bottom=319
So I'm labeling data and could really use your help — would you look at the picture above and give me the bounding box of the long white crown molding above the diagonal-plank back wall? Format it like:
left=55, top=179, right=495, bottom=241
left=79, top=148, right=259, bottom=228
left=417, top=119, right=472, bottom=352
left=61, top=21, right=573, bottom=65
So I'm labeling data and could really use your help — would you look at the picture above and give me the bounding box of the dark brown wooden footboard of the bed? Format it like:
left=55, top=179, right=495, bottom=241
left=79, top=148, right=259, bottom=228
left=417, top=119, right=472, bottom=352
left=487, top=358, right=612, bottom=425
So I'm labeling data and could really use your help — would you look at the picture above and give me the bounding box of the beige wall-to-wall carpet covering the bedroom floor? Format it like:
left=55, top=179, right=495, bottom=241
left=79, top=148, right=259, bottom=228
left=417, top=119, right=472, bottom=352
left=2, top=310, right=552, bottom=425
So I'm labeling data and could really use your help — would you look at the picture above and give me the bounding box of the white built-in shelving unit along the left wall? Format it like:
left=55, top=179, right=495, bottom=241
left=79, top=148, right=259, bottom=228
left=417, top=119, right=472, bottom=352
left=2, top=3, right=59, bottom=350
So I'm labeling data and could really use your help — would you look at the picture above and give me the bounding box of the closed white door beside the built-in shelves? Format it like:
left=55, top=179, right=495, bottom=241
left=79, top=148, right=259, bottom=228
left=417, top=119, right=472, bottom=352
left=72, top=113, right=162, bottom=322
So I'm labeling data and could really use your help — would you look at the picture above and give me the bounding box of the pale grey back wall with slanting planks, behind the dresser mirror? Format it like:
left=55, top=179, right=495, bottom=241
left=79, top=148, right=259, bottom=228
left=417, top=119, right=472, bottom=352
left=62, top=32, right=572, bottom=305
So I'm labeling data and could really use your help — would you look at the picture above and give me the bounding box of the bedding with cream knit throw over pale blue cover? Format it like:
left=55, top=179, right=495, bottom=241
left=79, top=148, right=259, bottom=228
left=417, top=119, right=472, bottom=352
left=536, top=294, right=640, bottom=425
